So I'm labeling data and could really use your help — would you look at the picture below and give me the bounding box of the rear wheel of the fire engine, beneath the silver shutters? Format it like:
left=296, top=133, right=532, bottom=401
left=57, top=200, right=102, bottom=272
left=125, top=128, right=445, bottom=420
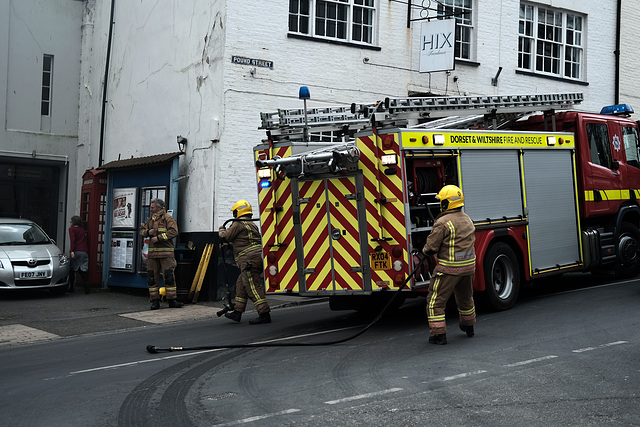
left=484, top=242, right=520, bottom=310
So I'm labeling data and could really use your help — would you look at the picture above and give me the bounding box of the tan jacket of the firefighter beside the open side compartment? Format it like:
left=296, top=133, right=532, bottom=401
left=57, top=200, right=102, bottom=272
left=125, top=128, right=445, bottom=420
left=422, top=208, right=476, bottom=276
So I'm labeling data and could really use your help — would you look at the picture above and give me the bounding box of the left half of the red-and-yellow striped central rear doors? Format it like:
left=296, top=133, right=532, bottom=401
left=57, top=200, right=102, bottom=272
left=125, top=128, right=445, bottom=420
left=299, top=180, right=332, bottom=291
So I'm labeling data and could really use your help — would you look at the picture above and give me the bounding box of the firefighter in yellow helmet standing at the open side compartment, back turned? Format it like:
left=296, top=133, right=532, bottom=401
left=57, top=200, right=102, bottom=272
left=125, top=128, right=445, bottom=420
left=422, top=185, right=476, bottom=344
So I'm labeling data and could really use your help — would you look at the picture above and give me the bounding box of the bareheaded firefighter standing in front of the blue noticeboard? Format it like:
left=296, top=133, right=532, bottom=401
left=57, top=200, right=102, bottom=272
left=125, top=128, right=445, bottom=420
left=140, top=198, right=183, bottom=310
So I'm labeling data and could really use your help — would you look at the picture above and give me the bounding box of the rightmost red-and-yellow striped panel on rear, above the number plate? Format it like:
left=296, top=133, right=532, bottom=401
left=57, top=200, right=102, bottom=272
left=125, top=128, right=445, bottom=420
left=358, top=137, right=408, bottom=290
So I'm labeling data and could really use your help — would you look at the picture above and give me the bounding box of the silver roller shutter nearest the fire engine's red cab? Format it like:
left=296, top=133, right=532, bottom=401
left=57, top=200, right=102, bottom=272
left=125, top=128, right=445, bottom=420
left=524, top=150, right=580, bottom=272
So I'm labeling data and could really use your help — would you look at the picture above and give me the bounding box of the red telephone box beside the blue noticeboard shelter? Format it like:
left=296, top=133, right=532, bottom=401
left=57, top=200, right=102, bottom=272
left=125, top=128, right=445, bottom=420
left=80, top=169, right=107, bottom=286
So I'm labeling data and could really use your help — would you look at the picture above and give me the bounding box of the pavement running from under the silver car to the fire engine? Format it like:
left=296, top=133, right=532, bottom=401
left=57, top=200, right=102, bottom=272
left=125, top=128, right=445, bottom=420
left=0, top=288, right=328, bottom=349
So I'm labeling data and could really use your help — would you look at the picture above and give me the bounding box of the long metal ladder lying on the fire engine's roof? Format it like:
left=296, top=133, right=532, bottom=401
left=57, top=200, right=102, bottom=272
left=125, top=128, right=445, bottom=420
left=260, top=93, right=583, bottom=142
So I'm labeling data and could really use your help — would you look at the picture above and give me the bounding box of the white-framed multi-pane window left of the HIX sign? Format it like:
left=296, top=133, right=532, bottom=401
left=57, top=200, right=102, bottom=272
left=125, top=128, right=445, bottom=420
left=289, top=0, right=376, bottom=44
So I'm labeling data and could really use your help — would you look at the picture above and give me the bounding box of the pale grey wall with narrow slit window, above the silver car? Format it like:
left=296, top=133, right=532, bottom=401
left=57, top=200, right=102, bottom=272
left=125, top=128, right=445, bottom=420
left=0, top=0, right=84, bottom=242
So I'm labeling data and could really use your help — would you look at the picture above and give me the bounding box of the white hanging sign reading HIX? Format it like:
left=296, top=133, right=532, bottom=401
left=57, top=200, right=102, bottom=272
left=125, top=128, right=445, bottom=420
left=420, top=19, right=456, bottom=73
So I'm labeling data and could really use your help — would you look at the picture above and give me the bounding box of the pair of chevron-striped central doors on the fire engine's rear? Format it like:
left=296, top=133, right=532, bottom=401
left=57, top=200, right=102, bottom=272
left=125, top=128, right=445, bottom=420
left=294, top=176, right=364, bottom=292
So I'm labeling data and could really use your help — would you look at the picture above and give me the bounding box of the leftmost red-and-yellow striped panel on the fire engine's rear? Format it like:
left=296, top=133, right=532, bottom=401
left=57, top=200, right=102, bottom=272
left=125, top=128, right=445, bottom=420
left=256, top=147, right=298, bottom=292
